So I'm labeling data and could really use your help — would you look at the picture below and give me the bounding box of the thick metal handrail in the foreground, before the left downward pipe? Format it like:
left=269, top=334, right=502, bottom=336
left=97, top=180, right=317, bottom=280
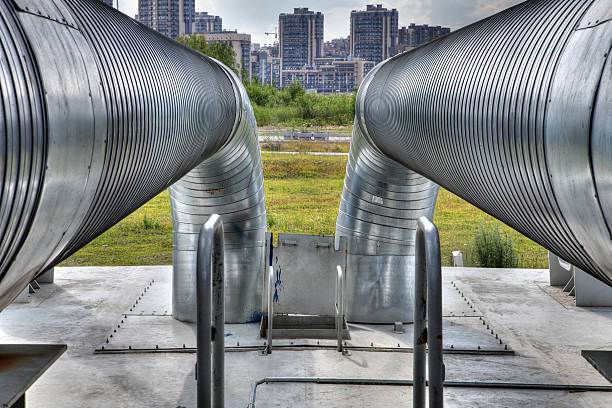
left=196, top=214, right=225, bottom=408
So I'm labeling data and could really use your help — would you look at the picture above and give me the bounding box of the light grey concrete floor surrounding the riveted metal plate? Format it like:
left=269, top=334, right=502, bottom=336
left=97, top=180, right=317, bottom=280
left=0, top=266, right=612, bottom=408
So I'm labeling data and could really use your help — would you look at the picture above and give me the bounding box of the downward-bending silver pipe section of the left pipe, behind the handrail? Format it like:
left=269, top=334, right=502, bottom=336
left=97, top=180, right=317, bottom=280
left=170, top=65, right=267, bottom=323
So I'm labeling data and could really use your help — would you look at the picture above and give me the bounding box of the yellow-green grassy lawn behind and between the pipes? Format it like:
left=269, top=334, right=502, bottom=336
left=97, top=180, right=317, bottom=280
left=62, top=151, right=548, bottom=268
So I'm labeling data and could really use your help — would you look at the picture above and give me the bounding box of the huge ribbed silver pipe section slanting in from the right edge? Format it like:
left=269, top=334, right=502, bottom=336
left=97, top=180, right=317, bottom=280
left=347, top=0, right=612, bottom=285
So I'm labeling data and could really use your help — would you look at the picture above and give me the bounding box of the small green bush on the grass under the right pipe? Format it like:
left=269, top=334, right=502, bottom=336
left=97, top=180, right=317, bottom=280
left=473, top=225, right=518, bottom=268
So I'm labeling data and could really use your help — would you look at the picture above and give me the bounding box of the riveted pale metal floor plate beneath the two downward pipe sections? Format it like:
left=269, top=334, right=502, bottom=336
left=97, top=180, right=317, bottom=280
left=96, top=275, right=512, bottom=354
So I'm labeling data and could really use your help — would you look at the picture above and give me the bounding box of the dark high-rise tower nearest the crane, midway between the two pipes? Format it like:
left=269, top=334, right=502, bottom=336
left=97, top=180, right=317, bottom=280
left=278, top=8, right=323, bottom=69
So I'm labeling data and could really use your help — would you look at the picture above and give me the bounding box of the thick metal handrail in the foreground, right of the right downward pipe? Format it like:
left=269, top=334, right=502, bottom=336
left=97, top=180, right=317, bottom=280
left=412, top=217, right=444, bottom=408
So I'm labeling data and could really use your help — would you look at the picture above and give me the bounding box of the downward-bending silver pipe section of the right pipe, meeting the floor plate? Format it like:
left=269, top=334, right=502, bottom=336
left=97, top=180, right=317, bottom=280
left=336, top=107, right=438, bottom=323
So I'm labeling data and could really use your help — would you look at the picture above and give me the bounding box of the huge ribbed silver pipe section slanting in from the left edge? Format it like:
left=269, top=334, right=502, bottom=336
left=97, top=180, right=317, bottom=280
left=0, top=0, right=265, bottom=309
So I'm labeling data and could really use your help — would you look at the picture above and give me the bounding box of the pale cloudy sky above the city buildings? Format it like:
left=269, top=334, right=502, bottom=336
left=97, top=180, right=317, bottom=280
left=114, top=0, right=522, bottom=44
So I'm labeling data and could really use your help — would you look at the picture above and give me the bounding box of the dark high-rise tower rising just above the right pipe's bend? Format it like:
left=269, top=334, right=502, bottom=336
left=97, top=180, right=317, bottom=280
left=351, top=4, right=398, bottom=63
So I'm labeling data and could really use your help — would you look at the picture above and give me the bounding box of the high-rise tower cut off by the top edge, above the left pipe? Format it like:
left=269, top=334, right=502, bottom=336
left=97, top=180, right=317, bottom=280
left=138, top=0, right=195, bottom=38
